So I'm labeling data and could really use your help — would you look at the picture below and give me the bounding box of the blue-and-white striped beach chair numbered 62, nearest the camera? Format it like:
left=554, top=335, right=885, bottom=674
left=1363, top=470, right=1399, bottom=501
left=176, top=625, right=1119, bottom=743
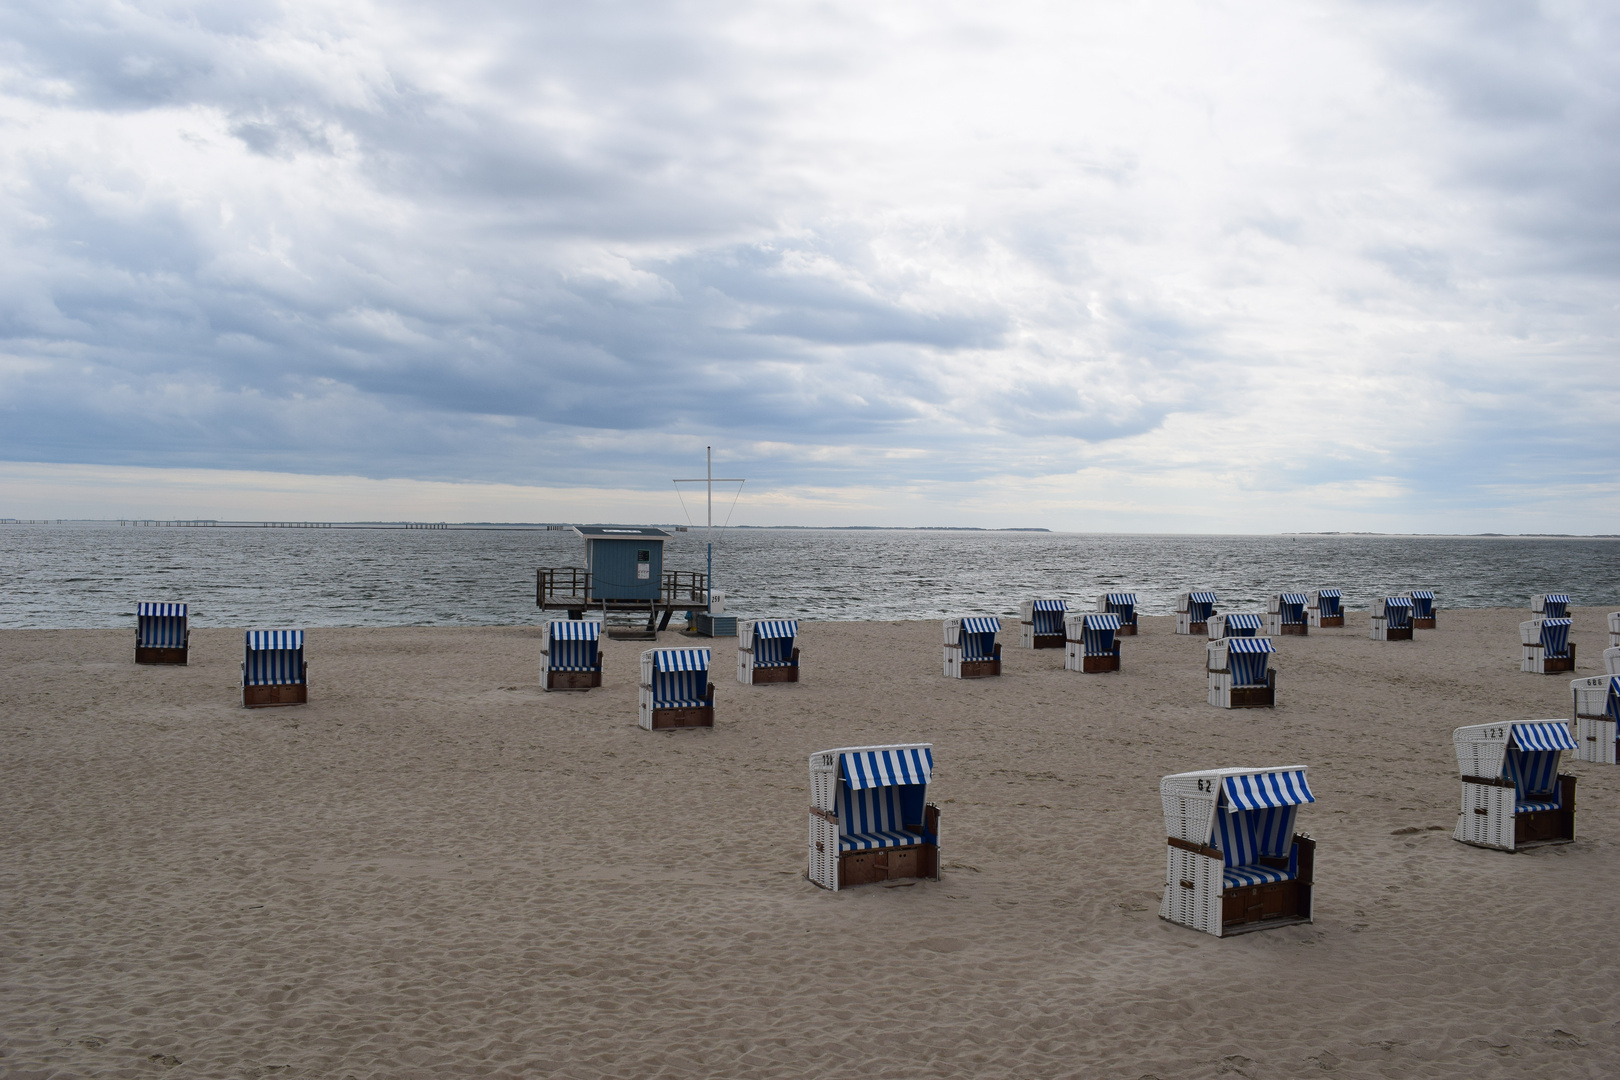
left=1158, top=766, right=1315, bottom=938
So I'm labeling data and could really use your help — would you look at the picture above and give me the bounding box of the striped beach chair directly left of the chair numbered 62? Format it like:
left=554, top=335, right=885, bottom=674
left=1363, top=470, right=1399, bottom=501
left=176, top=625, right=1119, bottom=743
left=810, top=743, right=940, bottom=892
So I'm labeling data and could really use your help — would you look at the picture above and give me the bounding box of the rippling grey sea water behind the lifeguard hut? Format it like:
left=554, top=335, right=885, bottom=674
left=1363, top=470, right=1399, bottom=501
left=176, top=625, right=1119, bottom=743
left=0, top=525, right=1620, bottom=628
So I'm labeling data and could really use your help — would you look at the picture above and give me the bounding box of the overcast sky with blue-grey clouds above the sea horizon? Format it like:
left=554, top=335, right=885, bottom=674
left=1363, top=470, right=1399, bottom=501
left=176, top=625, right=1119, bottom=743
left=0, top=0, right=1620, bottom=533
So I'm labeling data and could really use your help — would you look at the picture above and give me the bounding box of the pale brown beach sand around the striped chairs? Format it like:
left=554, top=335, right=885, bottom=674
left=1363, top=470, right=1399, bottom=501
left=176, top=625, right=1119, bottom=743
left=0, top=609, right=1620, bottom=1080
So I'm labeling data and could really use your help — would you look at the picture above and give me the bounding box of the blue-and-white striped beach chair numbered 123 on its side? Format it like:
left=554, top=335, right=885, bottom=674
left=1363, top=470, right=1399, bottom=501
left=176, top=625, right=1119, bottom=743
left=1452, top=721, right=1578, bottom=852
